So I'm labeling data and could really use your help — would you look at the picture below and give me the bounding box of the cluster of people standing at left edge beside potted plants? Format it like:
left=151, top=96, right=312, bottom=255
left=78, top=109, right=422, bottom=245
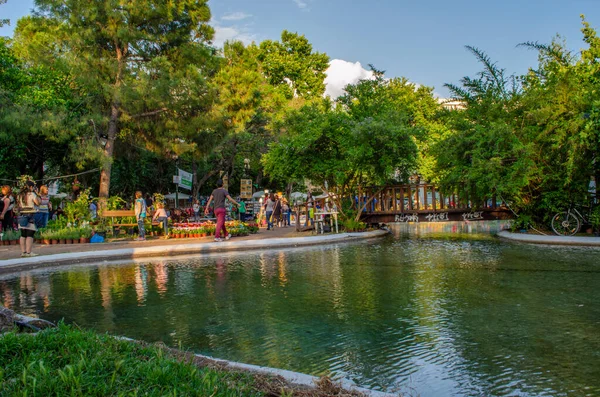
left=0, top=180, right=52, bottom=257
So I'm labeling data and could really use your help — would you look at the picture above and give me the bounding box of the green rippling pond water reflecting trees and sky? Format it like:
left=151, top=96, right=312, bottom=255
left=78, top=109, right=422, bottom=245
left=0, top=222, right=600, bottom=397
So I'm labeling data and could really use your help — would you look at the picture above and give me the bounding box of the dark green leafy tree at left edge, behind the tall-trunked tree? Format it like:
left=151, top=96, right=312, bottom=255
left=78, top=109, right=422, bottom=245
left=0, top=39, right=89, bottom=179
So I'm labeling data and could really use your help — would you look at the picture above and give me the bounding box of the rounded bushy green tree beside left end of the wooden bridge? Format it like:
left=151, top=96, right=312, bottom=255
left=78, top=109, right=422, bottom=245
left=263, top=74, right=422, bottom=220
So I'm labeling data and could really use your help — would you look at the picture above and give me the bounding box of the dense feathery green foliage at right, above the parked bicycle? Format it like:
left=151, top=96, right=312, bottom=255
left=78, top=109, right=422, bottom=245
left=434, top=20, right=600, bottom=221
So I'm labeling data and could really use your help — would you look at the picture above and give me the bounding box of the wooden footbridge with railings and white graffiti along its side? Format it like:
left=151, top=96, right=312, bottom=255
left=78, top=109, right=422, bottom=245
left=355, top=184, right=512, bottom=223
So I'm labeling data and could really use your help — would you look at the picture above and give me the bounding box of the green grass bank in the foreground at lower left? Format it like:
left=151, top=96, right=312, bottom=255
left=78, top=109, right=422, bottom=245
left=0, top=324, right=360, bottom=396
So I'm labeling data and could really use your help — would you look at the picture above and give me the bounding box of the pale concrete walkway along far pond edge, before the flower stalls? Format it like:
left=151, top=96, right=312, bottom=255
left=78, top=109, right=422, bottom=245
left=0, top=228, right=389, bottom=273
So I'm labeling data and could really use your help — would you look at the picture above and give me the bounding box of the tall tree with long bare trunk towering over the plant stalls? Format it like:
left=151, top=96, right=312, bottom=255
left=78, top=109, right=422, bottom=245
left=16, top=0, right=214, bottom=197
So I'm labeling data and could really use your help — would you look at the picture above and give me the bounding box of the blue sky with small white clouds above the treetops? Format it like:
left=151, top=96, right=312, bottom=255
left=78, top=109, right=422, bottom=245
left=0, top=0, right=600, bottom=96
